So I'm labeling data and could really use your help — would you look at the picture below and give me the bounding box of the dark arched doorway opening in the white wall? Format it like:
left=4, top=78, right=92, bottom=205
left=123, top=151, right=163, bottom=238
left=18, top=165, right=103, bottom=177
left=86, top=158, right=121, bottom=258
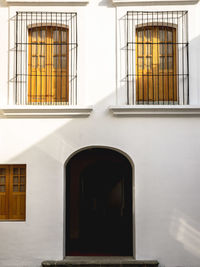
left=65, top=147, right=133, bottom=256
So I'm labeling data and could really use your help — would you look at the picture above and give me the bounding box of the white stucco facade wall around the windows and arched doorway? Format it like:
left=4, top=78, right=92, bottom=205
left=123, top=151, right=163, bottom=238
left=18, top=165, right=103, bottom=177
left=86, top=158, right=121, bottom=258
left=0, top=0, right=200, bottom=267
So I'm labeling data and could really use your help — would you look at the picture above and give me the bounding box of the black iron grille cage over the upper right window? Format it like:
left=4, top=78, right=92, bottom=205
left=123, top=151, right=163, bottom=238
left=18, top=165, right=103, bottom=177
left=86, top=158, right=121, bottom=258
left=121, top=11, right=189, bottom=105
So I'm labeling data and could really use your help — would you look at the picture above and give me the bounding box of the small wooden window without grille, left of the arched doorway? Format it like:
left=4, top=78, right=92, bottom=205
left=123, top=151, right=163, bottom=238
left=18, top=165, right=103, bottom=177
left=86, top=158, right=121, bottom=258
left=0, top=165, right=26, bottom=221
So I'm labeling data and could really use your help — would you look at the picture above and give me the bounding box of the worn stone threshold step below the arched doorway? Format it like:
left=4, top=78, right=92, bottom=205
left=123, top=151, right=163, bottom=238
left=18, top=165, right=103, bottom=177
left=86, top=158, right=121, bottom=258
left=42, top=256, right=159, bottom=267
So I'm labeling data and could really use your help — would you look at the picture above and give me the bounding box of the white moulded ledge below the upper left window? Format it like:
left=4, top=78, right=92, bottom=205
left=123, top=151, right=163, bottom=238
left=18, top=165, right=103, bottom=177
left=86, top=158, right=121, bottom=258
left=0, top=105, right=93, bottom=118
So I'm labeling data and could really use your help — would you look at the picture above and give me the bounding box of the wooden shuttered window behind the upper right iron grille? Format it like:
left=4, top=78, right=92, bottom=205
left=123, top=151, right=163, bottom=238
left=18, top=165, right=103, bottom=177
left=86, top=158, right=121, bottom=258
left=136, top=26, right=177, bottom=103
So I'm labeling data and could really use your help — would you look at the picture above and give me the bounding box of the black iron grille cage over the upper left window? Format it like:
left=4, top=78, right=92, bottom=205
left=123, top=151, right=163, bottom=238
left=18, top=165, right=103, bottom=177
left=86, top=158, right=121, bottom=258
left=10, top=12, right=78, bottom=105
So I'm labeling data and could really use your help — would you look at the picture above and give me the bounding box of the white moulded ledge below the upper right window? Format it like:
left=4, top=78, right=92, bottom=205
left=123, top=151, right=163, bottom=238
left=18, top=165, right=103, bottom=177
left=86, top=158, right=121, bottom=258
left=109, top=105, right=200, bottom=117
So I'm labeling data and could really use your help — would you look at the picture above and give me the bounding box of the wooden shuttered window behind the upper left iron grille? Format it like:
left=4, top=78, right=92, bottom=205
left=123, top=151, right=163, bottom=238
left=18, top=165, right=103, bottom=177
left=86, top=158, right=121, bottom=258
left=28, top=26, right=69, bottom=104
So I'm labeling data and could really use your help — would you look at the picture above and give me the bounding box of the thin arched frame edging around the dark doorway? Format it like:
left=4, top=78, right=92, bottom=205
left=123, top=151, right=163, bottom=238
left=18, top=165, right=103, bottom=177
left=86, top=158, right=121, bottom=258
left=63, top=145, right=136, bottom=259
